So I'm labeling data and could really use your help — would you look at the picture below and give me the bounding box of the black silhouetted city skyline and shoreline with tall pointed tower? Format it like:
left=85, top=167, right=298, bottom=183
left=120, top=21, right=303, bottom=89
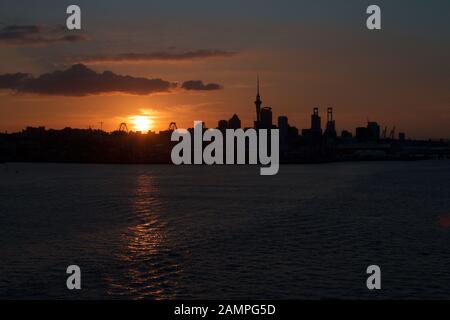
left=0, top=79, right=450, bottom=163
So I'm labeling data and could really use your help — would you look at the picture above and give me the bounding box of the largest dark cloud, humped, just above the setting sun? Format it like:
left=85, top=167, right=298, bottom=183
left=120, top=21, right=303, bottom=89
left=0, top=64, right=177, bottom=96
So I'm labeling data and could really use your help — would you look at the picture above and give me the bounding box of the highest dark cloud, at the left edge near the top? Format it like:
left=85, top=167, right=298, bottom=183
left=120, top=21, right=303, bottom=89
left=0, top=25, right=88, bottom=46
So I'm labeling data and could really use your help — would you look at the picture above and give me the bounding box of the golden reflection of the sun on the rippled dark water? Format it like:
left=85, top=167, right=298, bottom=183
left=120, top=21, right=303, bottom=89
left=107, top=174, right=181, bottom=299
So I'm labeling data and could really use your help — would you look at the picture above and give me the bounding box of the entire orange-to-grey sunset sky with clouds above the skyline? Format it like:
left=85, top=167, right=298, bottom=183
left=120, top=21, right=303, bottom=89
left=0, top=0, right=450, bottom=138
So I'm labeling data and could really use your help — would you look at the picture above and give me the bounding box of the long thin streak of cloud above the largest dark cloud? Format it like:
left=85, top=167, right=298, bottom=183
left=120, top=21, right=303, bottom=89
left=79, top=50, right=236, bottom=64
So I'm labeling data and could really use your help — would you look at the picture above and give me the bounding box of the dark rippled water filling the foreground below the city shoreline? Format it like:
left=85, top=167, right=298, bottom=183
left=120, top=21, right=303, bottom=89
left=0, top=161, right=450, bottom=299
